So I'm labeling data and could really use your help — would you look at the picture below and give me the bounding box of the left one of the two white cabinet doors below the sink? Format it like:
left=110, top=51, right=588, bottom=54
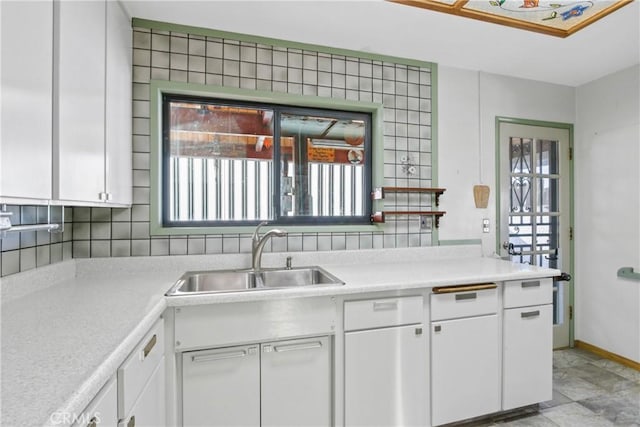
left=182, top=345, right=258, bottom=427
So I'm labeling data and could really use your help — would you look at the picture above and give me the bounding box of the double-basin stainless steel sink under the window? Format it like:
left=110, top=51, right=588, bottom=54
left=166, top=266, right=344, bottom=296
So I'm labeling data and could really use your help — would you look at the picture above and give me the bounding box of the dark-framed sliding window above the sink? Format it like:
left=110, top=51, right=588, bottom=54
left=162, top=94, right=372, bottom=227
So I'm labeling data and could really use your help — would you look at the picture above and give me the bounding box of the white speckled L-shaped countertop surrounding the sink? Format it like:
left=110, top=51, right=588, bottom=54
left=1, top=247, right=560, bottom=427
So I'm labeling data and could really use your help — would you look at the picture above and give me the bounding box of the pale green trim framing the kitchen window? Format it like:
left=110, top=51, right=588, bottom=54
left=149, top=80, right=384, bottom=236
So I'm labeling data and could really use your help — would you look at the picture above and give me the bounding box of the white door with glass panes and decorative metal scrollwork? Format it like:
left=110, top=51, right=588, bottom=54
left=497, top=119, right=573, bottom=348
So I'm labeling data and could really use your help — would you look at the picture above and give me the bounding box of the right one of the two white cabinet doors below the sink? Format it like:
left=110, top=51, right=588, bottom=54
left=261, top=337, right=332, bottom=426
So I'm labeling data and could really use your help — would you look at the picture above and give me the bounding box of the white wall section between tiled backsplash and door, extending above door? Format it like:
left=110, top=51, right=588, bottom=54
left=438, top=67, right=575, bottom=255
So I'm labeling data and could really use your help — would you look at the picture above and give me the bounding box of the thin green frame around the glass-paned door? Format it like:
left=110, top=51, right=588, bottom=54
left=495, top=116, right=575, bottom=347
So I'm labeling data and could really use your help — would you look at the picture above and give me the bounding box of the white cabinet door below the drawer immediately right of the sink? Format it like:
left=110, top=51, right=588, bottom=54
left=344, top=325, right=427, bottom=427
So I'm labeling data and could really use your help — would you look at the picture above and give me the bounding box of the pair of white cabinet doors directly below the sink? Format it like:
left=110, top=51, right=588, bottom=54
left=182, top=336, right=332, bottom=427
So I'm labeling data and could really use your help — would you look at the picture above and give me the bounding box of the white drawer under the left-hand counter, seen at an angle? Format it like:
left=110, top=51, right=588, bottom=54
left=118, top=319, right=164, bottom=419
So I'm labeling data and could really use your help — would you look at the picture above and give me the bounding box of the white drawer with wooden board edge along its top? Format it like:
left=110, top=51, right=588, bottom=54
left=431, top=284, right=498, bottom=321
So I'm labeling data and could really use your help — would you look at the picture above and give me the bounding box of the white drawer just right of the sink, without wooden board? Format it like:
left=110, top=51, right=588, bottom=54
left=344, top=296, right=423, bottom=331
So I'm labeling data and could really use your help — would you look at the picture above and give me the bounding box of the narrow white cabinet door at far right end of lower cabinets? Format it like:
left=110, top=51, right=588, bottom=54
left=502, top=305, right=553, bottom=410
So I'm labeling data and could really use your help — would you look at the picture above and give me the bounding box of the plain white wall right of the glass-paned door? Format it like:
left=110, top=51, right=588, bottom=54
left=575, top=66, right=640, bottom=362
